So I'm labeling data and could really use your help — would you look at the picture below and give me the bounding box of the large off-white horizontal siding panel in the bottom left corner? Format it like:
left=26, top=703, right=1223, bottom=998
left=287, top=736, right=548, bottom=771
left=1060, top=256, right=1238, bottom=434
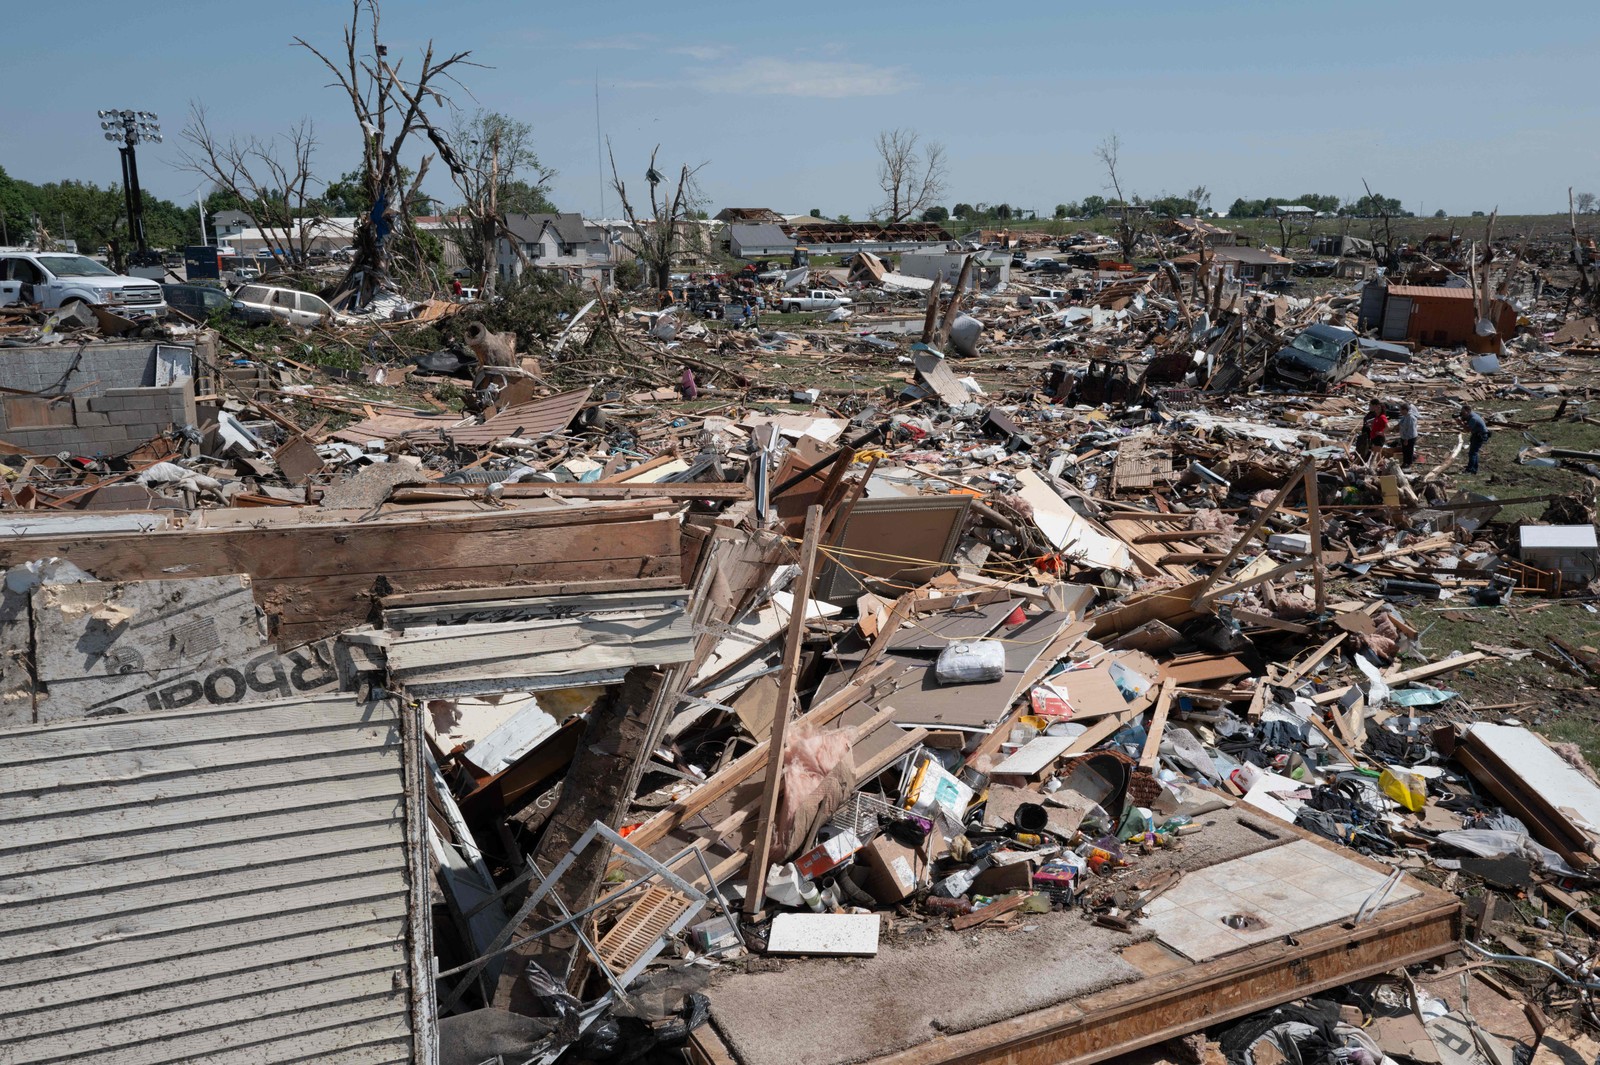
left=0, top=696, right=430, bottom=1065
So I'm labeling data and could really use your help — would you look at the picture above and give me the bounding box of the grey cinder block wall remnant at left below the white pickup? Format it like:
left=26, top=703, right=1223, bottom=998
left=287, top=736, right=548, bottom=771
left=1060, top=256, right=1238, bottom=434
left=0, top=341, right=195, bottom=456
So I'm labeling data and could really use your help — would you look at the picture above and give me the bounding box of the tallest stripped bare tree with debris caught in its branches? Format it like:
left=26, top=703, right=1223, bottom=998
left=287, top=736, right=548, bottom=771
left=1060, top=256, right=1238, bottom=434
left=294, top=0, right=478, bottom=305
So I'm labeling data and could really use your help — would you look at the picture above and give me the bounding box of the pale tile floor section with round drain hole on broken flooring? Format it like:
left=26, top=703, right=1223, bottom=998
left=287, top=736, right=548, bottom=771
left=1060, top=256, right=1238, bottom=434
left=1141, top=840, right=1421, bottom=961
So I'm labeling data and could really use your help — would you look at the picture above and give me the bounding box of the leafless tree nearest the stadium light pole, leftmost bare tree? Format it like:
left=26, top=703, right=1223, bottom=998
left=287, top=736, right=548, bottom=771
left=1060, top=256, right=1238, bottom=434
left=179, top=102, right=317, bottom=269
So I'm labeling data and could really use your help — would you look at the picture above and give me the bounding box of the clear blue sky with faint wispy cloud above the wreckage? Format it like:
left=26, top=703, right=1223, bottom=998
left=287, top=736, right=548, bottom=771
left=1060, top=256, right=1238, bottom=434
left=0, top=0, right=1600, bottom=217
